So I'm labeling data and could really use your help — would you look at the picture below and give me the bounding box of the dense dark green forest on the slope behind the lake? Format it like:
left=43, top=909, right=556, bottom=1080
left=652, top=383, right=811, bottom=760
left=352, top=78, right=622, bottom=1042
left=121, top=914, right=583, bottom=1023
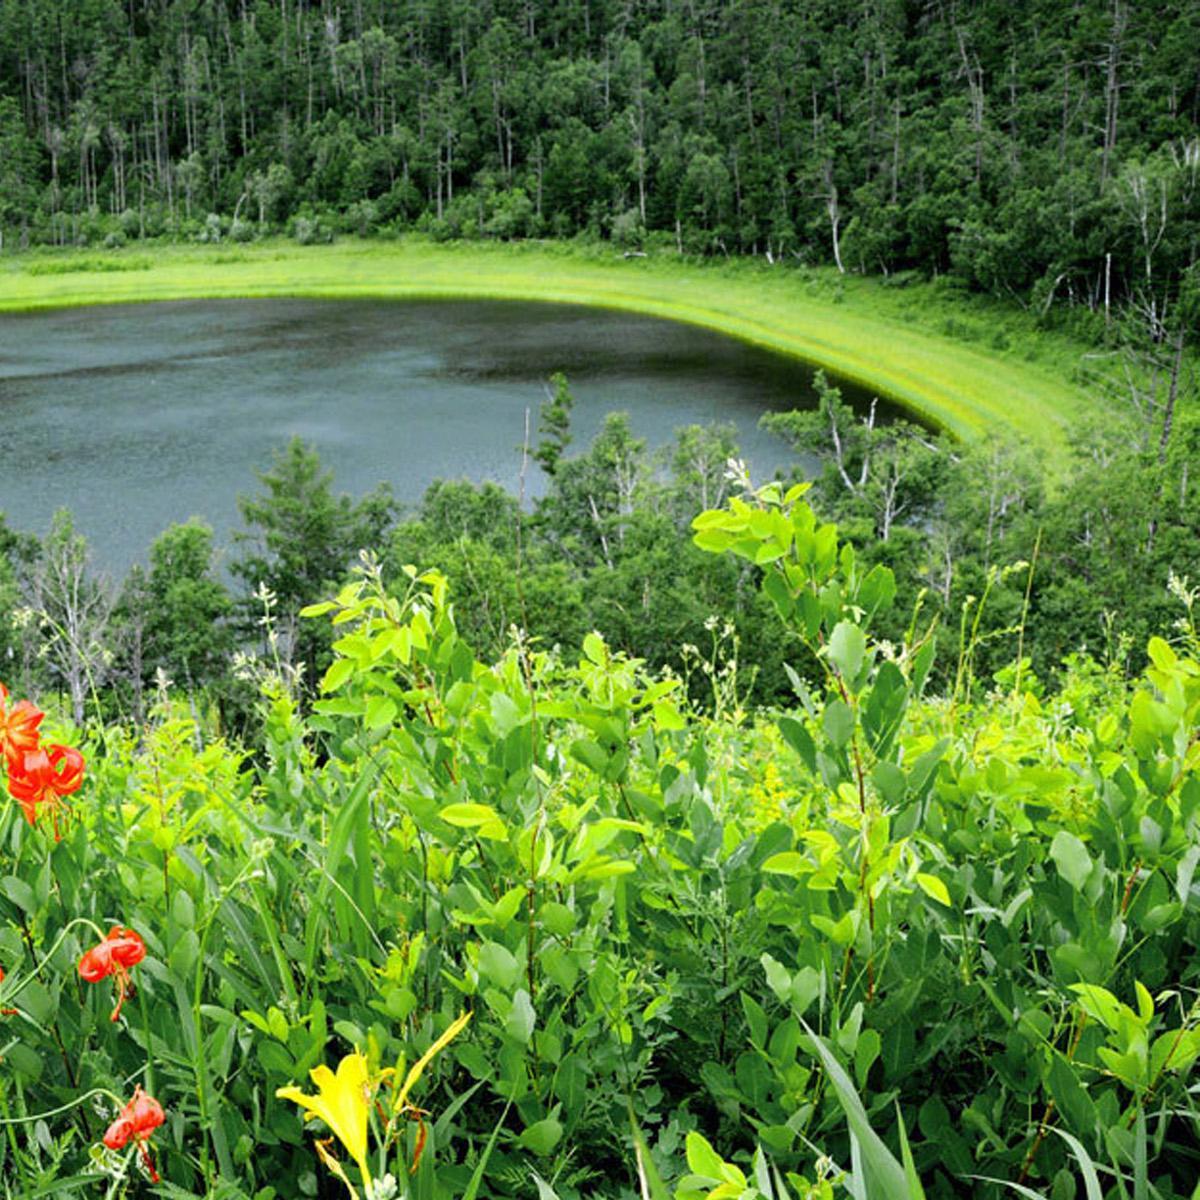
left=0, top=0, right=1200, bottom=319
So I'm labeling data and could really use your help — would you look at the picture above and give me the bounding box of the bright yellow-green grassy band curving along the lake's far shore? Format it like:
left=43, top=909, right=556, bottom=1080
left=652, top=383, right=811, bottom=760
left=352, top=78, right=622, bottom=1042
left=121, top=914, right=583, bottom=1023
left=0, top=240, right=1090, bottom=461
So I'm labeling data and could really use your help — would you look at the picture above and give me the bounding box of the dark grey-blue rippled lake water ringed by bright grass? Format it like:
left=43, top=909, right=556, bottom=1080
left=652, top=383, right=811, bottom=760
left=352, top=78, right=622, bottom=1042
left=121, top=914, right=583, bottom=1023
left=0, top=300, right=892, bottom=571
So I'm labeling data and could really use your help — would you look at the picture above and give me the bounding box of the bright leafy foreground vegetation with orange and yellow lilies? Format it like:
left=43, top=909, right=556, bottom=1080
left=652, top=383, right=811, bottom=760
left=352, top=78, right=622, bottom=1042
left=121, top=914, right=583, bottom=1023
left=0, top=485, right=1200, bottom=1200
